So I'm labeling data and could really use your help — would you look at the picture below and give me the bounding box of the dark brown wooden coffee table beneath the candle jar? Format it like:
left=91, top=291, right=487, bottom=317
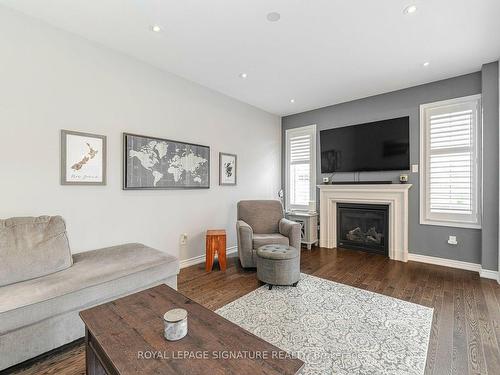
left=80, top=285, right=304, bottom=375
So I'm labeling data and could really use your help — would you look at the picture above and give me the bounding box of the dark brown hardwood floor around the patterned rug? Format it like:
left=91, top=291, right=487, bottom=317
left=4, top=247, right=500, bottom=375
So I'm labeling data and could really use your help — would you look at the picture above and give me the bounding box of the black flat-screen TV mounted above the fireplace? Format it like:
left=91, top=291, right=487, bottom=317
left=319, top=116, right=410, bottom=173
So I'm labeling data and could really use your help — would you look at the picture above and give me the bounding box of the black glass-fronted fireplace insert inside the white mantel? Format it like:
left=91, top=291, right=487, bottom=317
left=337, top=203, right=389, bottom=256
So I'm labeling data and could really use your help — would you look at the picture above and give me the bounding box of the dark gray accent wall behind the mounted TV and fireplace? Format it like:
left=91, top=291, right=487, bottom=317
left=281, top=73, right=488, bottom=269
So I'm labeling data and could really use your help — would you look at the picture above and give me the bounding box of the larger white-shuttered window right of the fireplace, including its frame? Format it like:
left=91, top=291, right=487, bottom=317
left=420, top=95, right=481, bottom=228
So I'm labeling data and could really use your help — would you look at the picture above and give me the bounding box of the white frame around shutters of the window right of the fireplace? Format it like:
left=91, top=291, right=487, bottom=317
left=419, top=94, right=482, bottom=229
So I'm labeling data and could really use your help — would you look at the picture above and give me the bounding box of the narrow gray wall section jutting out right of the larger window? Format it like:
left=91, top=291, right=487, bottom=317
left=481, top=62, right=499, bottom=270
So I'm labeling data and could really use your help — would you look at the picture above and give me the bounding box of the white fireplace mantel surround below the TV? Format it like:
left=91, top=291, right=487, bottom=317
left=318, top=184, right=412, bottom=262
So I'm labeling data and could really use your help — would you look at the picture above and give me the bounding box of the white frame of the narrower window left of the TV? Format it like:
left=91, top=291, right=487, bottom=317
left=285, top=124, right=317, bottom=212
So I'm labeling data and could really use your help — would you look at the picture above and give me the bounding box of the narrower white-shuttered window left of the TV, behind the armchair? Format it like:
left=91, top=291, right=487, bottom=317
left=285, top=125, right=316, bottom=210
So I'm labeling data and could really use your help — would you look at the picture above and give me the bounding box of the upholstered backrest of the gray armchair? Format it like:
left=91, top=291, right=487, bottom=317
left=238, top=200, right=284, bottom=234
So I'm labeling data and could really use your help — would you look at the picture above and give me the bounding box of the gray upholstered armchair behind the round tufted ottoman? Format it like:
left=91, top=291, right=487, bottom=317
left=236, top=200, right=300, bottom=268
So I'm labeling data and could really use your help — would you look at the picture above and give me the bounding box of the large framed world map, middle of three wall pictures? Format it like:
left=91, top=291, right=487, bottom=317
left=123, top=133, right=210, bottom=190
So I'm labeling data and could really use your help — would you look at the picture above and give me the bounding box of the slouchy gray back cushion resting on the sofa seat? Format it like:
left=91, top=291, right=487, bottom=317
left=0, top=216, right=72, bottom=286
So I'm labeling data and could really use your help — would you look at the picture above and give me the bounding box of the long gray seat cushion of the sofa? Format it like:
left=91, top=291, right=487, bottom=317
left=0, top=243, right=179, bottom=335
